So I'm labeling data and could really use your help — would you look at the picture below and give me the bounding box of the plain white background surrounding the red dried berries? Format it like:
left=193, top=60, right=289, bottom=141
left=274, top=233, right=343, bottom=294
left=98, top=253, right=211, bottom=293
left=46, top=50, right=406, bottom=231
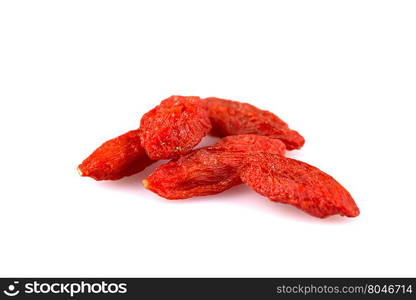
left=0, top=0, right=416, bottom=276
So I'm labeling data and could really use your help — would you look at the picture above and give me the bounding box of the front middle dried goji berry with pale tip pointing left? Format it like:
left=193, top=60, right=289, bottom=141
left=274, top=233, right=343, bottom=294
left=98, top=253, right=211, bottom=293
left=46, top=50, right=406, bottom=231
left=143, top=135, right=285, bottom=199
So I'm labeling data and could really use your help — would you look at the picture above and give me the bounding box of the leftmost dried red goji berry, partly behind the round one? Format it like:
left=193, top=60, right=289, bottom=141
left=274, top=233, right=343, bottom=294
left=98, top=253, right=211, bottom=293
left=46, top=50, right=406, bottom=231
left=78, top=130, right=154, bottom=180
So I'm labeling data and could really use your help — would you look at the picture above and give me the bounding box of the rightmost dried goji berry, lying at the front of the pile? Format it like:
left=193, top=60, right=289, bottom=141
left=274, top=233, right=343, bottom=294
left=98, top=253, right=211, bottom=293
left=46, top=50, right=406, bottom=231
left=239, top=153, right=360, bottom=218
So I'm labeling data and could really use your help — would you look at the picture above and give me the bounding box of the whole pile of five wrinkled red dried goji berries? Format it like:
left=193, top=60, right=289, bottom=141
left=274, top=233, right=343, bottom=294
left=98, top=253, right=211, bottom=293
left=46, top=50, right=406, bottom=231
left=78, top=96, right=360, bottom=218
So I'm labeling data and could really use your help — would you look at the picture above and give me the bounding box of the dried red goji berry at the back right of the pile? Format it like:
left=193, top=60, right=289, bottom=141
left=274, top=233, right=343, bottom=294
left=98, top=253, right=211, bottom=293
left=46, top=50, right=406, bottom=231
left=203, top=97, right=305, bottom=150
